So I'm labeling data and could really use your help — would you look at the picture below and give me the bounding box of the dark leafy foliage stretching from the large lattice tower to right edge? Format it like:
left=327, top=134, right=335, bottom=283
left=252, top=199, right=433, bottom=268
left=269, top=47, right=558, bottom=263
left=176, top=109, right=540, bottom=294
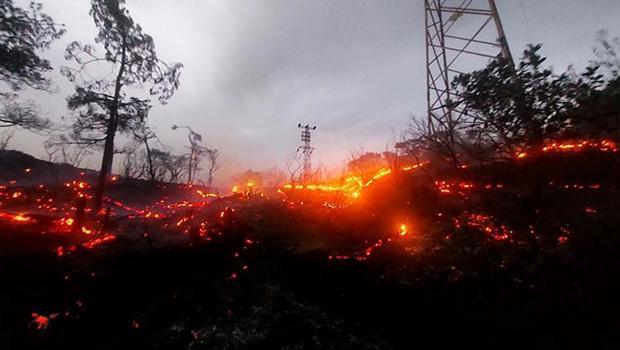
left=453, top=41, right=620, bottom=154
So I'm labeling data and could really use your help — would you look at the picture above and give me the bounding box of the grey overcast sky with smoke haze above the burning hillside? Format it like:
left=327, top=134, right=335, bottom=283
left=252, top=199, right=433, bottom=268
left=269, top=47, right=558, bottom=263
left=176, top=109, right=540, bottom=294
left=11, top=0, right=620, bottom=186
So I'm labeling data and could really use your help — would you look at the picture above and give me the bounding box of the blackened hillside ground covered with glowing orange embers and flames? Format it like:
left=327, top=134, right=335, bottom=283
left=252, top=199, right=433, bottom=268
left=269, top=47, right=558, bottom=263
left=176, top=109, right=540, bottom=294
left=0, top=145, right=620, bottom=349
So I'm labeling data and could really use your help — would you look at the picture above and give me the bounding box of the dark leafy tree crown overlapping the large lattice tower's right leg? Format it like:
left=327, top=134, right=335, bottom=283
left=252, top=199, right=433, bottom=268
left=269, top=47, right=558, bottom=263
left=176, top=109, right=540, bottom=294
left=453, top=45, right=573, bottom=148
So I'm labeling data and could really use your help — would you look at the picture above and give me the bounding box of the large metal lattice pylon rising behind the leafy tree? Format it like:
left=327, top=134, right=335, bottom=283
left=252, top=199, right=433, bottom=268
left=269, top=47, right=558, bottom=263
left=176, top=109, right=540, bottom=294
left=425, top=0, right=514, bottom=134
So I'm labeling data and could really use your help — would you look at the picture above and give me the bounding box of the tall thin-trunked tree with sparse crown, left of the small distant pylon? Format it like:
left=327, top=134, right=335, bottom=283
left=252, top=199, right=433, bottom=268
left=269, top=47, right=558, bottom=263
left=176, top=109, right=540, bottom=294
left=62, top=0, right=182, bottom=212
